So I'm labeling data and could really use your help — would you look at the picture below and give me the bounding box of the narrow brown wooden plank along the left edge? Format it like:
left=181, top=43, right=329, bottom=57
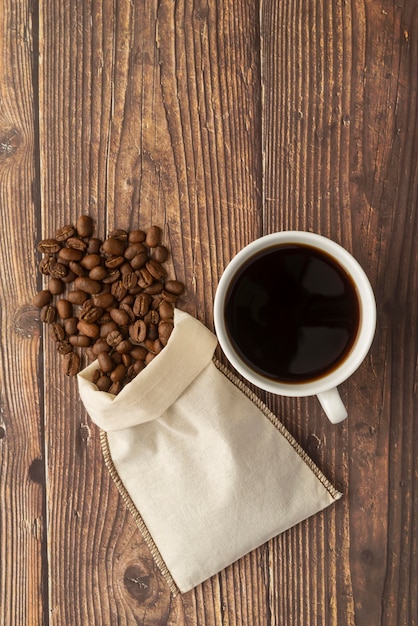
left=0, top=1, right=47, bottom=626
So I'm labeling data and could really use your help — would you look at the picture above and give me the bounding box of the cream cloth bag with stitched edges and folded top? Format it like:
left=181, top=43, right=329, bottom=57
left=78, top=309, right=341, bottom=593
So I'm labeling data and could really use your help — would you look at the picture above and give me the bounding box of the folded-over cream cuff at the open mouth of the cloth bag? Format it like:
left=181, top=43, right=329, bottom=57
left=77, top=309, right=217, bottom=432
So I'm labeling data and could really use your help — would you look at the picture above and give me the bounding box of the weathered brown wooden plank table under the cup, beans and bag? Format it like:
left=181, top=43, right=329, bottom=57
left=0, top=0, right=418, bottom=626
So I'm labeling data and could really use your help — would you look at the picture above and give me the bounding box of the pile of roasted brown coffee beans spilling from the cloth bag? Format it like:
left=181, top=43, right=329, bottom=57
left=33, top=215, right=184, bottom=395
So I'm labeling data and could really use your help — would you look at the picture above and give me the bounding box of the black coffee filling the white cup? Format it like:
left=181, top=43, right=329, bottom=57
left=225, top=244, right=360, bottom=383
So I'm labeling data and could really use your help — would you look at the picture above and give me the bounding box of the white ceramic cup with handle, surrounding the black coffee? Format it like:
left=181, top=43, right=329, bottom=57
left=214, top=231, right=376, bottom=424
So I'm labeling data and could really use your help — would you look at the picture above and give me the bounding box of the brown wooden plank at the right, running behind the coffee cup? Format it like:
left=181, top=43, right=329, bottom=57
left=261, top=2, right=418, bottom=626
